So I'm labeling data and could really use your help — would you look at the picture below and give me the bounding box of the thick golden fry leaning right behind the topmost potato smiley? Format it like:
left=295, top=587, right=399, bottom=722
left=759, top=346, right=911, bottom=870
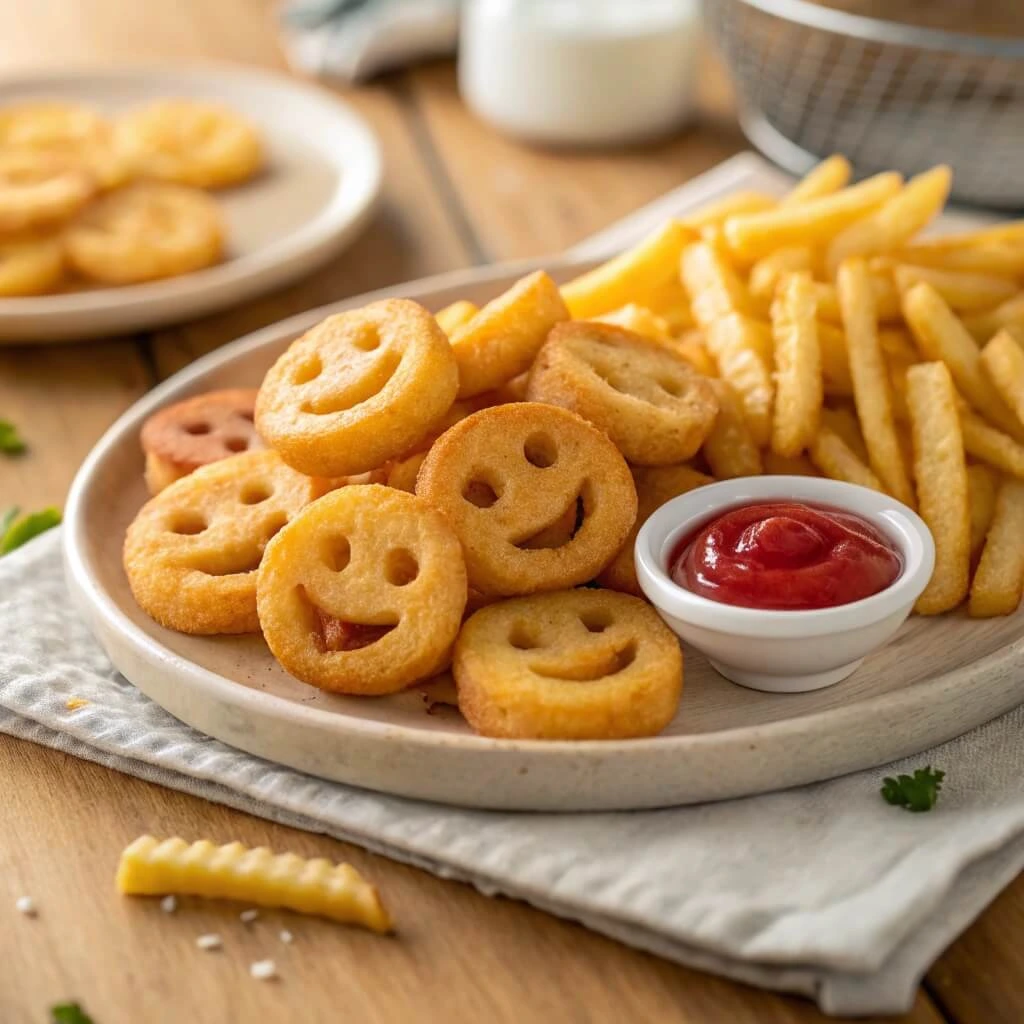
left=452, top=270, right=569, bottom=398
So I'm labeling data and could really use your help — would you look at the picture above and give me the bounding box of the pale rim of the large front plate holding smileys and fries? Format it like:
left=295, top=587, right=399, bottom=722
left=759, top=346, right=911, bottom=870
left=62, top=257, right=1024, bottom=758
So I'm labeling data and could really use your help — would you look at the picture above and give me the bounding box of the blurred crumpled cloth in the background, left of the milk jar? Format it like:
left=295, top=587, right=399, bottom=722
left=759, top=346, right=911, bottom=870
left=282, top=0, right=460, bottom=82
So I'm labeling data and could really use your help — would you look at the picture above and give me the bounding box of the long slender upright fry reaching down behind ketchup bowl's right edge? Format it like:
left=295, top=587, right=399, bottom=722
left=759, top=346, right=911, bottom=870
left=837, top=258, right=913, bottom=506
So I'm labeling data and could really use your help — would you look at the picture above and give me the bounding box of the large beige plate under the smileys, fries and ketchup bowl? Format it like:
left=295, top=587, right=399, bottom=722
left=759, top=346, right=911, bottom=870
left=65, top=158, right=1024, bottom=811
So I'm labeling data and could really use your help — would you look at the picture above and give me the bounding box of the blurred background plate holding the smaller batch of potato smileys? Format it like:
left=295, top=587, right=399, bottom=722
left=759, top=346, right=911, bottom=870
left=0, top=63, right=381, bottom=343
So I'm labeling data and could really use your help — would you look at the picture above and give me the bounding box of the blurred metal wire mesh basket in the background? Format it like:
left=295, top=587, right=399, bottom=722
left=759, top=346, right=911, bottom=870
left=705, top=0, right=1024, bottom=207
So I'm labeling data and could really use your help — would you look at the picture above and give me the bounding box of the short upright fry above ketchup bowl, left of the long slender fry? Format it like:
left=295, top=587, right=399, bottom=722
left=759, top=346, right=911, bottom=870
left=771, top=273, right=824, bottom=456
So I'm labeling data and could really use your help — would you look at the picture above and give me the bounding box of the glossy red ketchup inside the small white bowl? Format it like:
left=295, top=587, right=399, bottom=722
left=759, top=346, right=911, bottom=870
left=669, top=502, right=903, bottom=611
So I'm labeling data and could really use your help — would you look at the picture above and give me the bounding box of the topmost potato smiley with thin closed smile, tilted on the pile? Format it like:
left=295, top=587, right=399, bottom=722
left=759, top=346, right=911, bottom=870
left=256, top=299, right=459, bottom=476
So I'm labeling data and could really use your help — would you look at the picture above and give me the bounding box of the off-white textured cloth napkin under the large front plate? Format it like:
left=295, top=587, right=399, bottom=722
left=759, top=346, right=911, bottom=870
left=6, top=530, right=1024, bottom=1016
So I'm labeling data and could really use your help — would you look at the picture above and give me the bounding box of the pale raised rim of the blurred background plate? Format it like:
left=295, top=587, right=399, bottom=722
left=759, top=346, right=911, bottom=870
left=0, top=59, right=384, bottom=333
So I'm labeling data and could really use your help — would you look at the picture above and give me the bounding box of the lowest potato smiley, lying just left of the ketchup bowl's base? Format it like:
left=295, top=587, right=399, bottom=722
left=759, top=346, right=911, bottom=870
left=453, top=589, right=683, bottom=739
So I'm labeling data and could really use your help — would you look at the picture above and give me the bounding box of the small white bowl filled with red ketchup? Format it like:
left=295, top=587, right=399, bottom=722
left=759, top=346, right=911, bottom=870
left=634, top=476, right=935, bottom=693
